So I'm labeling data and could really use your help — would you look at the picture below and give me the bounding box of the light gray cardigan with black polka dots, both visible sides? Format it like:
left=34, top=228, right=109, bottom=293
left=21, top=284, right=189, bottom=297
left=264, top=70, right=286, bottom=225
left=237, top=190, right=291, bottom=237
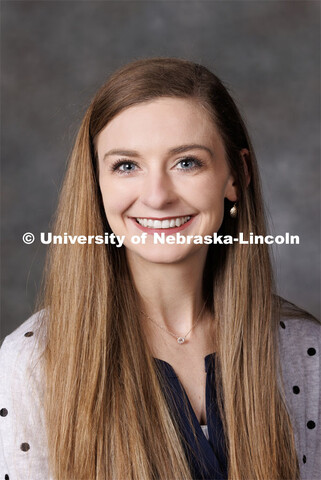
left=0, top=314, right=321, bottom=480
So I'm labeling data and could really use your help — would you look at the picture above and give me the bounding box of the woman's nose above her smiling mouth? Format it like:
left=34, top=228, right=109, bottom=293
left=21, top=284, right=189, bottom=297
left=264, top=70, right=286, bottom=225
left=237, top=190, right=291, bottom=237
left=140, top=172, right=177, bottom=209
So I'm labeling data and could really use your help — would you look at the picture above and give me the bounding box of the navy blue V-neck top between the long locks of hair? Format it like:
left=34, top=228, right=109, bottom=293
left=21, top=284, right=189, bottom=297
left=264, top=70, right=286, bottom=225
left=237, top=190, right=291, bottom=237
left=154, top=353, right=227, bottom=480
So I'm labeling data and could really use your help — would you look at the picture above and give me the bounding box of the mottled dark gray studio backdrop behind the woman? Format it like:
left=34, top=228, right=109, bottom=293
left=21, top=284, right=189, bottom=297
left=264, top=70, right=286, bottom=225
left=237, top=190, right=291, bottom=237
left=0, top=1, right=320, bottom=338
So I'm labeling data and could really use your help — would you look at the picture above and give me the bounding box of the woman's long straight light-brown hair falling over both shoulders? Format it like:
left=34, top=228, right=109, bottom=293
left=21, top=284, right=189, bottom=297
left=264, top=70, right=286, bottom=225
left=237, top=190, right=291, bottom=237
left=37, top=58, right=299, bottom=480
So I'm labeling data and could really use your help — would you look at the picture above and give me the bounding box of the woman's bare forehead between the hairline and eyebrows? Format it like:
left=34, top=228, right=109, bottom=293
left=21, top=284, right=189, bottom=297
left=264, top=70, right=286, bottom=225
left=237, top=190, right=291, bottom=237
left=96, top=97, right=221, bottom=156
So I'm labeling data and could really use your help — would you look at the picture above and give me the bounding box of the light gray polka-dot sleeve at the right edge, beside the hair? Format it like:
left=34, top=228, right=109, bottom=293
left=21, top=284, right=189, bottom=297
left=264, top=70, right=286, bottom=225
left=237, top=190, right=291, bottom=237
left=280, top=318, right=321, bottom=480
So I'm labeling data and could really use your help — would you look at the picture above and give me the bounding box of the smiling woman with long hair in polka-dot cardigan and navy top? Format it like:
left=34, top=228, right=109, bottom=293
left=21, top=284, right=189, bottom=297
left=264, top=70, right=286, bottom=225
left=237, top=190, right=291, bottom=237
left=1, top=58, right=320, bottom=480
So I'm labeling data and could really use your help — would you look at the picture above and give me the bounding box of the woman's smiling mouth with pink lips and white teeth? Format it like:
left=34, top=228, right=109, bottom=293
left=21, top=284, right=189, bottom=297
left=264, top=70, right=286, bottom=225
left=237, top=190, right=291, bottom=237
left=132, top=215, right=194, bottom=234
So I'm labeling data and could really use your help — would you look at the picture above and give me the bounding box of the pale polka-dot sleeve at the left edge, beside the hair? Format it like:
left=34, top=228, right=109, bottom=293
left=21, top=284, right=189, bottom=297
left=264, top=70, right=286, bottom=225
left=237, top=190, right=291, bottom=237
left=0, top=319, right=50, bottom=480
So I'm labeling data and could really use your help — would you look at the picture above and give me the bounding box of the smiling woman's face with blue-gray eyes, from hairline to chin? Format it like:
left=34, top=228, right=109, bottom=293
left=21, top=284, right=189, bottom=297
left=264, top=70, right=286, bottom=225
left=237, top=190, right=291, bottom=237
left=96, top=97, right=237, bottom=263
